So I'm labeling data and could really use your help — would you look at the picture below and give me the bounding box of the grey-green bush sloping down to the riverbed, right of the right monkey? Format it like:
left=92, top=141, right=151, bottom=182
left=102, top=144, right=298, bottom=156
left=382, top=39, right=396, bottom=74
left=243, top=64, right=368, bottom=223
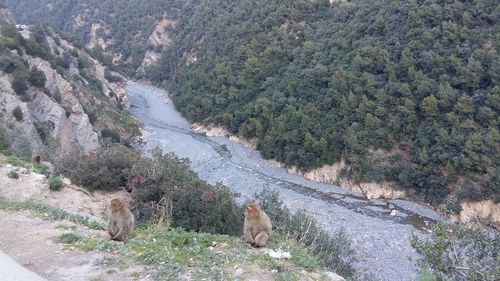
left=256, top=188, right=355, bottom=277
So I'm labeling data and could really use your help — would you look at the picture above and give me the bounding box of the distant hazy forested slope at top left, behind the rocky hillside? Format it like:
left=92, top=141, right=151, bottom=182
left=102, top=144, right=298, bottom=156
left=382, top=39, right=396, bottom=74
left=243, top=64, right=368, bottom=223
left=0, top=0, right=190, bottom=75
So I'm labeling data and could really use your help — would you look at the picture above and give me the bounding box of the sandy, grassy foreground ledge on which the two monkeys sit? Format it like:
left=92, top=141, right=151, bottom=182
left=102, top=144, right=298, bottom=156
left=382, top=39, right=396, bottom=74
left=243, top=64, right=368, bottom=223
left=0, top=154, right=344, bottom=281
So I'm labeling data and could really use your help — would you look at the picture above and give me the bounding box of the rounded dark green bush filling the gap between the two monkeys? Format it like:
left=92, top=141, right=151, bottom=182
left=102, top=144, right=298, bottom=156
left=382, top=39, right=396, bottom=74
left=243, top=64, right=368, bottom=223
left=132, top=149, right=243, bottom=235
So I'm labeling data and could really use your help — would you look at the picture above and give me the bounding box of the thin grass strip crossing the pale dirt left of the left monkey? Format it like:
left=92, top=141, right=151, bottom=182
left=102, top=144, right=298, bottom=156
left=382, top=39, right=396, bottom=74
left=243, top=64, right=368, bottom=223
left=0, top=196, right=105, bottom=230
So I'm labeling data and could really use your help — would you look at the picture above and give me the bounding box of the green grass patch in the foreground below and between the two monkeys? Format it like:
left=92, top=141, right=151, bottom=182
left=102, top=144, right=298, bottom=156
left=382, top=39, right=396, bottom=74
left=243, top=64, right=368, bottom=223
left=67, top=225, right=320, bottom=280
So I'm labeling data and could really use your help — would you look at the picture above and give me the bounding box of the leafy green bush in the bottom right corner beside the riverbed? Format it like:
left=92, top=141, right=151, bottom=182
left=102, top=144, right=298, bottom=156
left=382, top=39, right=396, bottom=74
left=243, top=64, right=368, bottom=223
left=411, top=223, right=500, bottom=281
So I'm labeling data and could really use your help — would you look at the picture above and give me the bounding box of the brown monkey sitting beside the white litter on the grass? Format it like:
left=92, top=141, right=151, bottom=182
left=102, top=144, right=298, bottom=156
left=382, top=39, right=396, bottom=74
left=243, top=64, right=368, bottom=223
left=243, top=203, right=272, bottom=247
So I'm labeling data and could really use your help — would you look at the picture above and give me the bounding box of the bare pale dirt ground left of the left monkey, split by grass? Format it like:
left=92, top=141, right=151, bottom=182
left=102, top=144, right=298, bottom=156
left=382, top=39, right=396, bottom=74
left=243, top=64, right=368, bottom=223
left=0, top=165, right=150, bottom=281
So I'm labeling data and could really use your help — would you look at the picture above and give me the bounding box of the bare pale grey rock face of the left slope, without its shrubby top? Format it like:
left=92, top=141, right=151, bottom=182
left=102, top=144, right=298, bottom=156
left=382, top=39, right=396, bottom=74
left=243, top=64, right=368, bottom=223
left=0, top=20, right=134, bottom=154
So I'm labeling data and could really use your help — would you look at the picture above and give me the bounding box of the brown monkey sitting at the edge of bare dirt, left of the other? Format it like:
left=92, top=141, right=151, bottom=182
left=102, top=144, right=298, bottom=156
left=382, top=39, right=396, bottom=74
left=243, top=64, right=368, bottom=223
left=108, top=198, right=134, bottom=241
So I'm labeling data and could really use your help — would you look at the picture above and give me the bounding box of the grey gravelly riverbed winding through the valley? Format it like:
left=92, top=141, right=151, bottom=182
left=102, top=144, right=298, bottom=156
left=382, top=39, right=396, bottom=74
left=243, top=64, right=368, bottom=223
left=128, top=82, right=445, bottom=280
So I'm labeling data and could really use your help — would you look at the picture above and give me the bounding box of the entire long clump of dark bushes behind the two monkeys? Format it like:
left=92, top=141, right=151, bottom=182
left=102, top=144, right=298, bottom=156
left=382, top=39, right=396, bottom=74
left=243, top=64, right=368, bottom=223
left=55, top=144, right=243, bottom=235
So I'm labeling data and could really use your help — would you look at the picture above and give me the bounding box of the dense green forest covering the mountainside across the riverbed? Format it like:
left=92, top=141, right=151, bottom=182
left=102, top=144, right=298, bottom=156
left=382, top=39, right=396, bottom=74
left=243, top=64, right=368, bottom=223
left=0, top=0, right=500, bottom=207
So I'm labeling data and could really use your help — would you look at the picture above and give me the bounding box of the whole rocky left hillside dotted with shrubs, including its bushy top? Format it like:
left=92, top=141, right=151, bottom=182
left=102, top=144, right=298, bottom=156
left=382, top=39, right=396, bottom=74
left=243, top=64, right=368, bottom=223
left=0, top=18, right=139, bottom=159
